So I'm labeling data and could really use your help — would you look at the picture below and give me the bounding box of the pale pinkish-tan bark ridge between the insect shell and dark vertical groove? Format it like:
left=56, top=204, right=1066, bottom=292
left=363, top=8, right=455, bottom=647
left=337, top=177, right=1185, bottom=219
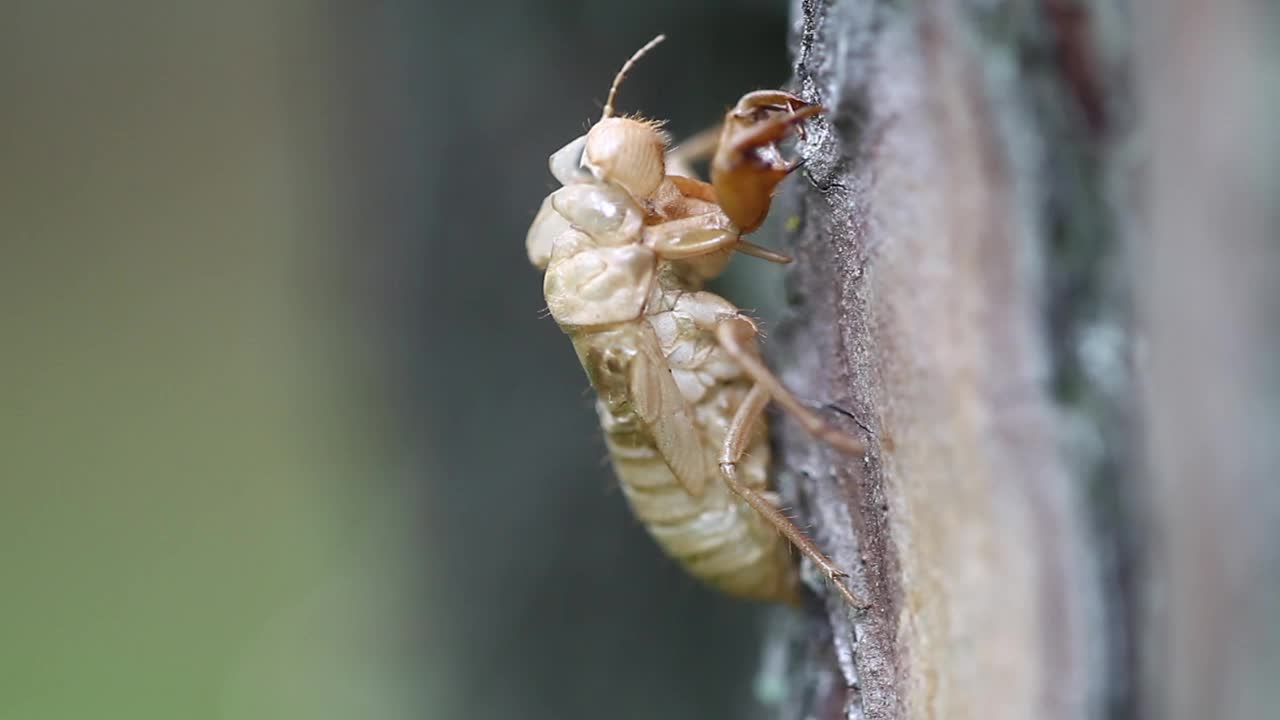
left=777, top=0, right=1103, bottom=720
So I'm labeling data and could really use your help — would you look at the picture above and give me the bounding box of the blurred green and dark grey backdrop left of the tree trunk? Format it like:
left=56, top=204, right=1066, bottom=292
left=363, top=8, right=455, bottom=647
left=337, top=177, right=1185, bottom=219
left=0, top=0, right=788, bottom=720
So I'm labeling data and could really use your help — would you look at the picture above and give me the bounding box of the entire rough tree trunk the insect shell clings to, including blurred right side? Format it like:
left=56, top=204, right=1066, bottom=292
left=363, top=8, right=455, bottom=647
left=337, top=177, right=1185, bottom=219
left=771, top=0, right=1280, bottom=720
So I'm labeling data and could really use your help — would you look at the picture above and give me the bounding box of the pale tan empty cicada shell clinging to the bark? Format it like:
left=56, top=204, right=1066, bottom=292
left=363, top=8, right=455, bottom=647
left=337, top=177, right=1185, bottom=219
left=526, top=36, right=864, bottom=606
